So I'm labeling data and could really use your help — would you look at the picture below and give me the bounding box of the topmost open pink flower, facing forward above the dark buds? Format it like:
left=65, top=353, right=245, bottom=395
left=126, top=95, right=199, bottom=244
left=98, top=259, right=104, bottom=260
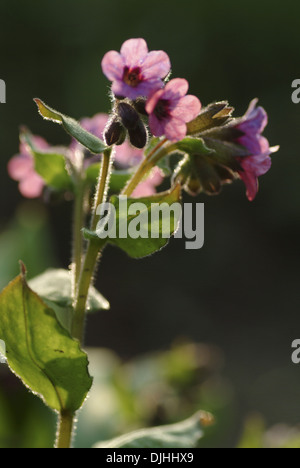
left=101, top=39, right=171, bottom=99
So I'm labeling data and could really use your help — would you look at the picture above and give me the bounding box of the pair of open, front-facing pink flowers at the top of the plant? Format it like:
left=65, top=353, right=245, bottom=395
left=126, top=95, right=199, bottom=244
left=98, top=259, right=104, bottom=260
left=102, top=39, right=201, bottom=142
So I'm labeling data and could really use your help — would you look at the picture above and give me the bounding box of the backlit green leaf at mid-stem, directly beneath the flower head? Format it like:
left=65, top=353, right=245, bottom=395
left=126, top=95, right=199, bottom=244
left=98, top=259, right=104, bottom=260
left=84, top=184, right=181, bottom=258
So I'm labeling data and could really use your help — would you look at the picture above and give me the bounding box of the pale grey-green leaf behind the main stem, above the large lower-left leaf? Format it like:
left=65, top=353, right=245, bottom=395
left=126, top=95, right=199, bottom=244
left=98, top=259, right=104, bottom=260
left=29, top=269, right=110, bottom=312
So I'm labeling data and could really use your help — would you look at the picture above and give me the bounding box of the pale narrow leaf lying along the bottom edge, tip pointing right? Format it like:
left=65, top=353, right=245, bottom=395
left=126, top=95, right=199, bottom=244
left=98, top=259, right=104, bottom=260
left=94, top=411, right=212, bottom=448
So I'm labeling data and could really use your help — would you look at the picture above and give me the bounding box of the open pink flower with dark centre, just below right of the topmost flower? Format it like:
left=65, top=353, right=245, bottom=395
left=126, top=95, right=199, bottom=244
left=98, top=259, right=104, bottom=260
left=146, top=78, right=201, bottom=141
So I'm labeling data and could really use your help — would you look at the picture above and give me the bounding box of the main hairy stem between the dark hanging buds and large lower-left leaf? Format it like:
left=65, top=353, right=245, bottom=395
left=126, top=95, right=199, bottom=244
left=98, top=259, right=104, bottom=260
left=72, top=149, right=111, bottom=342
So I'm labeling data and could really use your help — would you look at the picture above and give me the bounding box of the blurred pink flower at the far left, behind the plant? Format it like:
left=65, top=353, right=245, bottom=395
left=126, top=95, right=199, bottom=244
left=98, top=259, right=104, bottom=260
left=7, top=136, right=48, bottom=198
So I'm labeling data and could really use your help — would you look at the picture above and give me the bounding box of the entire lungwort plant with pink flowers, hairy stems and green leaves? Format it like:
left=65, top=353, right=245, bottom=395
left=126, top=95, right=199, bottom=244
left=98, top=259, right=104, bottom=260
left=0, top=39, right=277, bottom=448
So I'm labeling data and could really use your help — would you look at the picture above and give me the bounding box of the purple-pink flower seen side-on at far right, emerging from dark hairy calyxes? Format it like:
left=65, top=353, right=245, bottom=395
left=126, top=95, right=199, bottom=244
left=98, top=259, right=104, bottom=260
left=235, top=99, right=279, bottom=201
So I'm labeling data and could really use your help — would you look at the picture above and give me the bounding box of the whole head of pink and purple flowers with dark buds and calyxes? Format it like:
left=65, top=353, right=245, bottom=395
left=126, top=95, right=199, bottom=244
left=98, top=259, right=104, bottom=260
left=8, top=38, right=278, bottom=201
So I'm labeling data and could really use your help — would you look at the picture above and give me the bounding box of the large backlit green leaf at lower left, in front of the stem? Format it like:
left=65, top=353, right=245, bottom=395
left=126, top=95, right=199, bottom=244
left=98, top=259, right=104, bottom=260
left=0, top=272, right=92, bottom=412
